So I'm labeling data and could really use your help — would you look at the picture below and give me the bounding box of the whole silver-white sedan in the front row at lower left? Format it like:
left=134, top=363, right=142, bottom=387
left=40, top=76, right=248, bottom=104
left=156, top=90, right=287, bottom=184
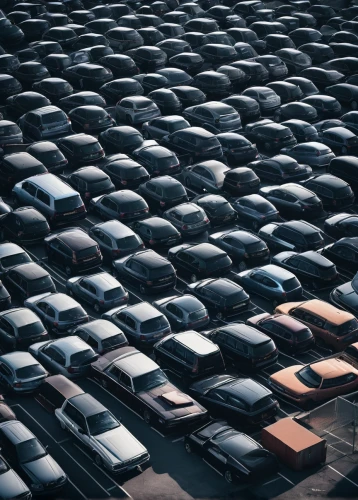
left=55, top=393, right=150, bottom=474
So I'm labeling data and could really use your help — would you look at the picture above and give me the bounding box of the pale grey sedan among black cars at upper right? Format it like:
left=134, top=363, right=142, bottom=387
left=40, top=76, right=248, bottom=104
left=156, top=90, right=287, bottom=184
left=280, top=141, right=336, bottom=167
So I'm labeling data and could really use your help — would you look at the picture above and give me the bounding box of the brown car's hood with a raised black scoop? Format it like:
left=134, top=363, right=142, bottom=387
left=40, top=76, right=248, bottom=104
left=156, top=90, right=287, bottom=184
left=138, top=383, right=205, bottom=420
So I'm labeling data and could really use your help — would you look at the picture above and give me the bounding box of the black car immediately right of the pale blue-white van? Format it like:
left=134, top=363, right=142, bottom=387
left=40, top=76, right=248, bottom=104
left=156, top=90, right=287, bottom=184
left=63, top=166, right=115, bottom=203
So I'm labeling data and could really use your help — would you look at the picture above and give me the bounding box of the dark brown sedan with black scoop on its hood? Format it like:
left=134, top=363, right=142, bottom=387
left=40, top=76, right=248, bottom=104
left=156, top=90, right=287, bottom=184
left=92, top=347, right=207, bottom=429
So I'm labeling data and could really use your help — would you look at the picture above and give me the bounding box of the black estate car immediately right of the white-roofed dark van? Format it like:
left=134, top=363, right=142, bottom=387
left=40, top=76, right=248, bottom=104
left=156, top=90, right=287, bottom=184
left=203, top=322, right=278, bottom=371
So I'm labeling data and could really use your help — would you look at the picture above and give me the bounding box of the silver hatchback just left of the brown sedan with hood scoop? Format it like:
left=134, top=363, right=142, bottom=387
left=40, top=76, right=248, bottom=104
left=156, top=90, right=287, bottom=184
left=29, top=335, right=98, bottom=378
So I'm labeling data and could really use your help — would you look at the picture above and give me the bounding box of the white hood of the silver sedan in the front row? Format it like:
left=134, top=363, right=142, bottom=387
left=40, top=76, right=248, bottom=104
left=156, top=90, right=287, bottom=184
left=94, top=425, right=146, bottom=462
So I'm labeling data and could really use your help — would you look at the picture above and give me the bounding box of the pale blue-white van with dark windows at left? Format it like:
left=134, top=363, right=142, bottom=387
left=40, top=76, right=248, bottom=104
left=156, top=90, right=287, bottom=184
left=12, top=173, right=87, bottom=226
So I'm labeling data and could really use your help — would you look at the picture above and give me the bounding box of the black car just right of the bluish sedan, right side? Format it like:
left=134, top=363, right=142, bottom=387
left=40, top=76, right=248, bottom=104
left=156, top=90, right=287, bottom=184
left=272, top=250, right=338, bottom=288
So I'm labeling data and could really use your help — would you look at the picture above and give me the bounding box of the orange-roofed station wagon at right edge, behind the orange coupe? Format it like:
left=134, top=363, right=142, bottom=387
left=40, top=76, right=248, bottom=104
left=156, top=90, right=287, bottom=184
left=275, top=299, right=358, bottom=352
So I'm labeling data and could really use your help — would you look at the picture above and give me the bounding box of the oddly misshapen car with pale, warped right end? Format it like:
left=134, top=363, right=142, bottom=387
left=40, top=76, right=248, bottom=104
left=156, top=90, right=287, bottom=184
left=182, top=160, right=230, bottom=194
